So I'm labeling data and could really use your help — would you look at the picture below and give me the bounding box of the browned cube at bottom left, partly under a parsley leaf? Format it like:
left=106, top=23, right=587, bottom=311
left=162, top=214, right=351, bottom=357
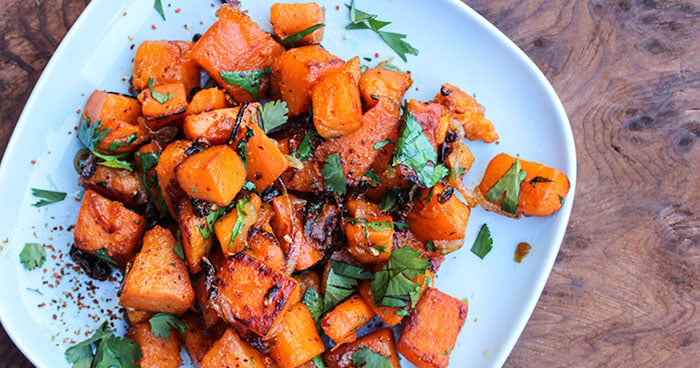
left=126, top=323, right=182, bottom=368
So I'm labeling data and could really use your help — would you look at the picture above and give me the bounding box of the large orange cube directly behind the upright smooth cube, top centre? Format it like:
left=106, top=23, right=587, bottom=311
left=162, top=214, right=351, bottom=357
left=271, top=45, right=345, bottom=116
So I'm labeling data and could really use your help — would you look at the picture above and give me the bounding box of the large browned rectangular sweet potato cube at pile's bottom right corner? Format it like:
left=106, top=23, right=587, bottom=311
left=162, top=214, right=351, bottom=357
left=397, top=288, right=468, bottom=368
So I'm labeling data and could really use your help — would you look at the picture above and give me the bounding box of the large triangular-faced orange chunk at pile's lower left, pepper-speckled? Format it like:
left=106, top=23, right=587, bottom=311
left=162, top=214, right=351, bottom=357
left=119, top=226, right=194, bottom=314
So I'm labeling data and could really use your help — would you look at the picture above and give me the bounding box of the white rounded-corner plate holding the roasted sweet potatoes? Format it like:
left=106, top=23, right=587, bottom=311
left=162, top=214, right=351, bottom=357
left=0, top=0, right=576, bottom=367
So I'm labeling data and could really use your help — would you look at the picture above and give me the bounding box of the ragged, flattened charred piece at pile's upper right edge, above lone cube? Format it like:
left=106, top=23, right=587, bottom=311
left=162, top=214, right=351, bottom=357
left=433, top=83, right=498, bottom=143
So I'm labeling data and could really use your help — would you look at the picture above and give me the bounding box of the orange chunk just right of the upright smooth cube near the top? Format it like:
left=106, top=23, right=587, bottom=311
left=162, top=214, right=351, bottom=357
left=360, top=65, right=413, bottom=110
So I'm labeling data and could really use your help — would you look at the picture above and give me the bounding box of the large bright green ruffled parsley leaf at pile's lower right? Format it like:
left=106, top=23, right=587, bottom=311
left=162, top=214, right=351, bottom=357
left=370, top=247, right=429, bottom=308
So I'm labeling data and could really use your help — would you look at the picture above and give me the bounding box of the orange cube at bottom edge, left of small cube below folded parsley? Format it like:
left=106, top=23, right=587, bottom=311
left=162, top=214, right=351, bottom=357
left=270, top=303, right=325, bottom=368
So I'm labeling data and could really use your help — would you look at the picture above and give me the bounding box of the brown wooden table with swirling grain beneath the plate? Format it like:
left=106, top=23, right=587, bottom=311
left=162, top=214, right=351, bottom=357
left=0, top=0, right=700, bottom=367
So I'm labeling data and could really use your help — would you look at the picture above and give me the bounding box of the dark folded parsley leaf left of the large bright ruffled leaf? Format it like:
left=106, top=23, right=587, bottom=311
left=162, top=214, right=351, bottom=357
left=323, top=260, right=372, bottom=311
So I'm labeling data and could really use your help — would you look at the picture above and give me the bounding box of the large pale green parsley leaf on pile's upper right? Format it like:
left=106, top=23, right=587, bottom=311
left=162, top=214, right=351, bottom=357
left=392, top=106, right=448, bottom=188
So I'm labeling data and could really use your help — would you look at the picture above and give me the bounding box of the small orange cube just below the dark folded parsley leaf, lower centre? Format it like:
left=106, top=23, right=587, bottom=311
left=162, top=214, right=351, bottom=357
left=321, top=295, right=375, bottom=345
